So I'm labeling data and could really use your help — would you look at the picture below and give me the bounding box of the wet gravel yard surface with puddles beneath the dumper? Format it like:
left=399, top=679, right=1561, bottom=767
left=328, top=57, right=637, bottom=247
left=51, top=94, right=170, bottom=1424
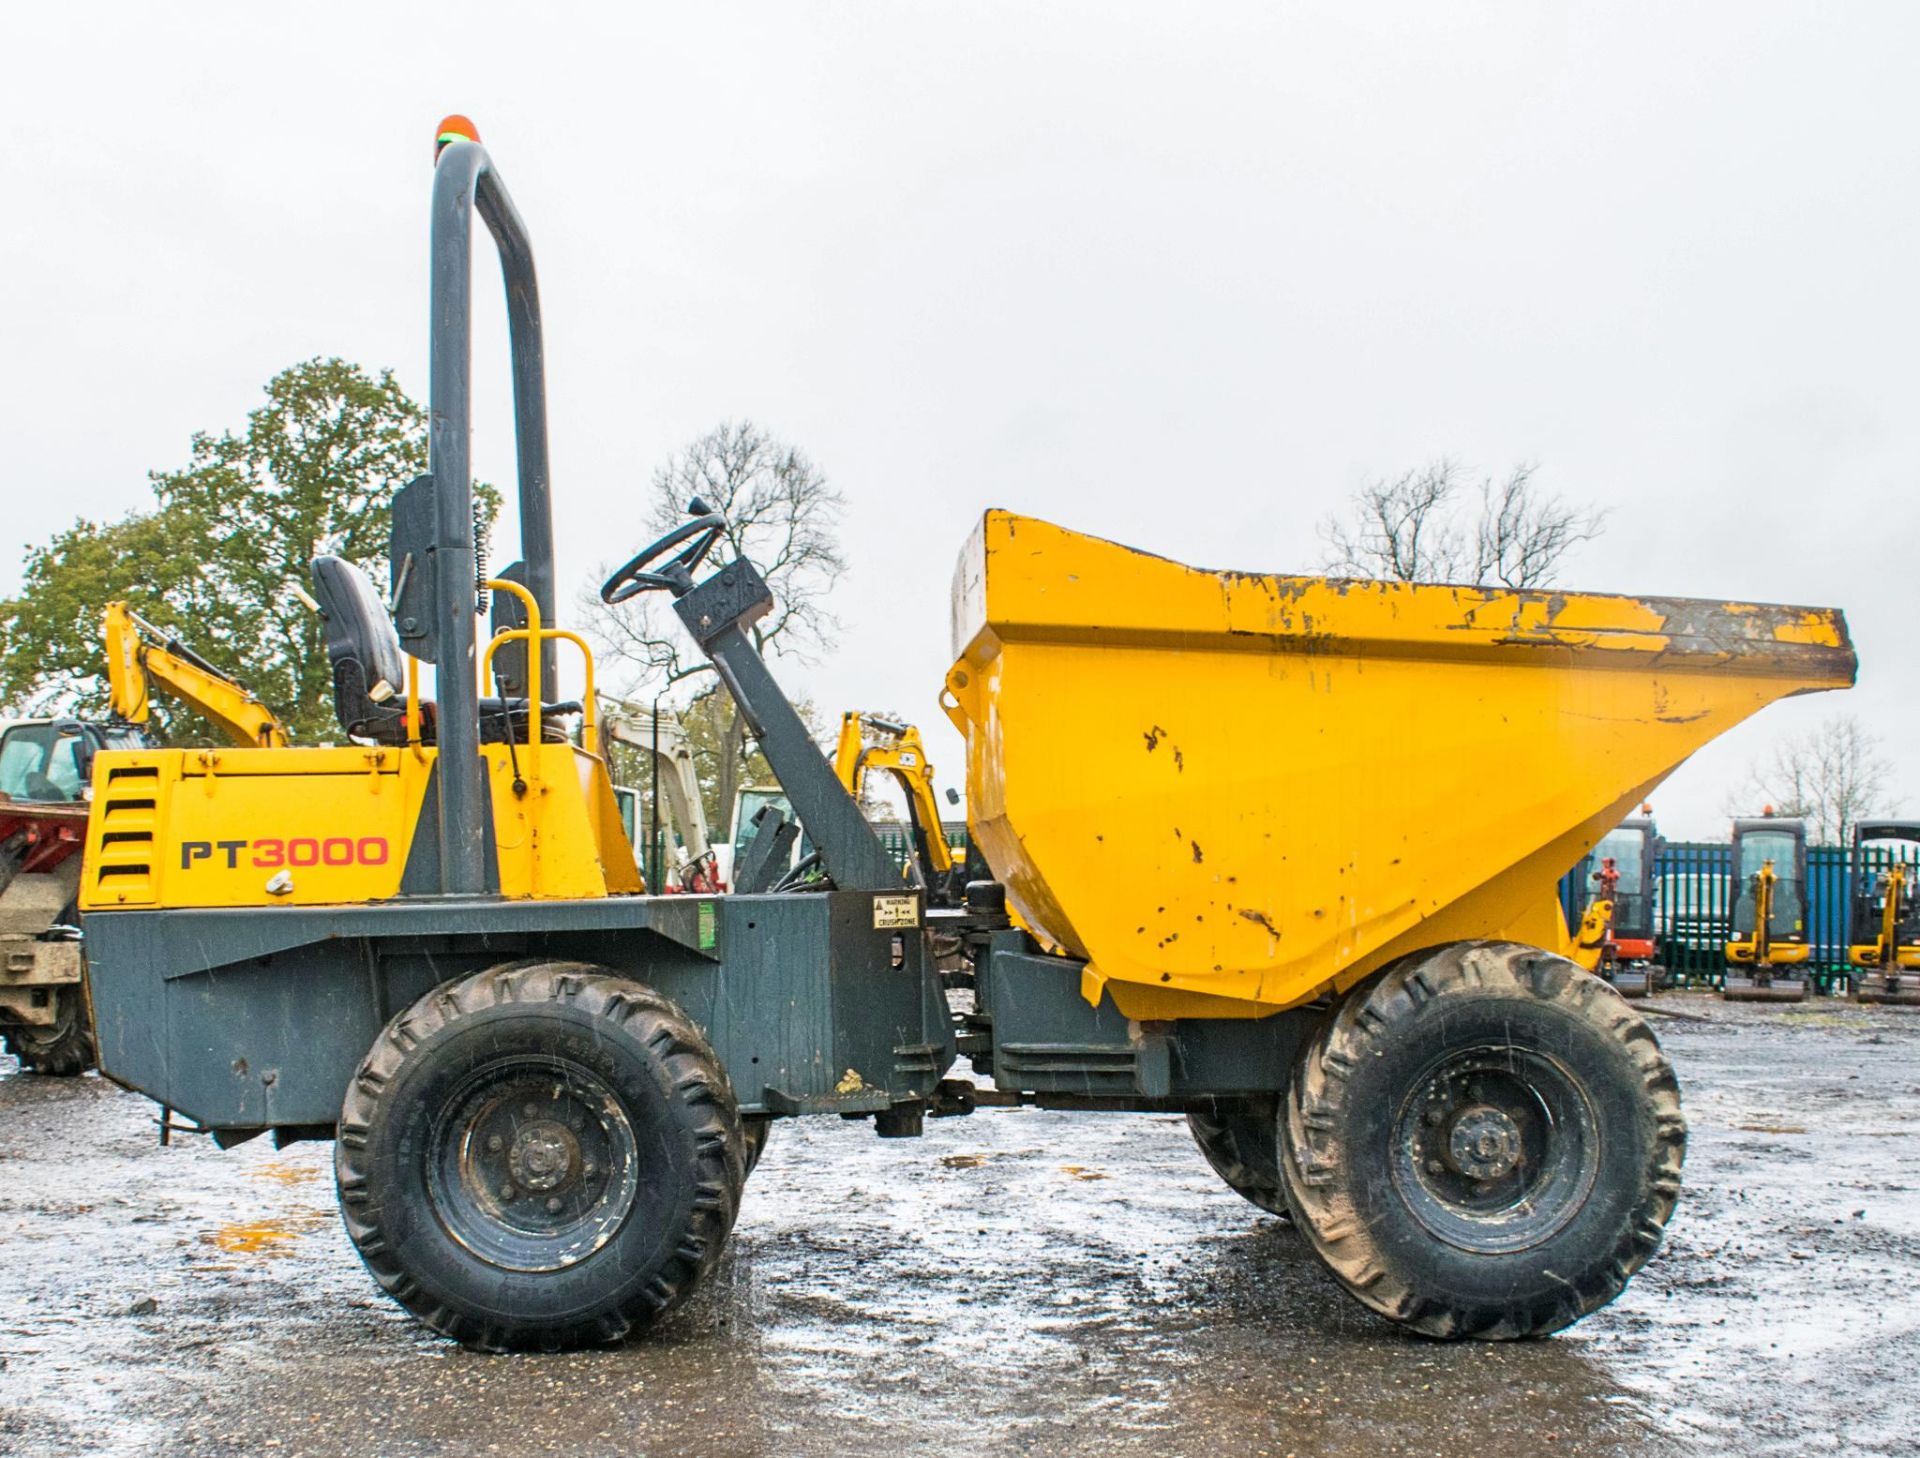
left=0, top=997, right=1920, bottom=1458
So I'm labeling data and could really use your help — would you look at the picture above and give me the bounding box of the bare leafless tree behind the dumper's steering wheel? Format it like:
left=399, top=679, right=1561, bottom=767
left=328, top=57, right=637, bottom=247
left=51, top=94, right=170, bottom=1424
left=584, top=421, right=847, bottom=826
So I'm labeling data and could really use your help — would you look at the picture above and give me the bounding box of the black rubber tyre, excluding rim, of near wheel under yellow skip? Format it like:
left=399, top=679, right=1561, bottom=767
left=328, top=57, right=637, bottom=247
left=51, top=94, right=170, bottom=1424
left=1281, top=941, right=1686, bottom=1341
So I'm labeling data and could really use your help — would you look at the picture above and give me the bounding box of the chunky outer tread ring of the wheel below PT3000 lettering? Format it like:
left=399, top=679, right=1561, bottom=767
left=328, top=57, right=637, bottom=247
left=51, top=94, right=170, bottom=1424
left=334, top=962, right=745, bottom=1352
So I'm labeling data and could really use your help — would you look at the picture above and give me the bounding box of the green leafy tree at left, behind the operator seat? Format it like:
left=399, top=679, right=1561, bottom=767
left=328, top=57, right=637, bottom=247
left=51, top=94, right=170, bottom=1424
left=0, top=359, right=497, bottom=740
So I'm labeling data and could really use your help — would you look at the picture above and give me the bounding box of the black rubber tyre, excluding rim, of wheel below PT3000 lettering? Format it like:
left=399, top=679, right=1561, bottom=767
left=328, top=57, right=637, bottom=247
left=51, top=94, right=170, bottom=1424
left=334, top=962, right=745, bottom=1352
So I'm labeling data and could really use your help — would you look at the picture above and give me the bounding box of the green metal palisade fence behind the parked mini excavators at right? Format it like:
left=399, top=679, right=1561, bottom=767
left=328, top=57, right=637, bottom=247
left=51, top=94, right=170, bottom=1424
left=1561, top=841, right=1920, bottom=991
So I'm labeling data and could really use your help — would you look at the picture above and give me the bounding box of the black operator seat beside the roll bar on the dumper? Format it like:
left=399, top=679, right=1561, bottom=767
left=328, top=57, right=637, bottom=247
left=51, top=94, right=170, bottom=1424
left=313, top=557, right=580, bottom=743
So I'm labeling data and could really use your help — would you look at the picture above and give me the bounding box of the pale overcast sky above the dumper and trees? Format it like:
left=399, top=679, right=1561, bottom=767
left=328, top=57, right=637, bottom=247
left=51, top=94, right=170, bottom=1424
left=0, top=0, right=1920, bottom=836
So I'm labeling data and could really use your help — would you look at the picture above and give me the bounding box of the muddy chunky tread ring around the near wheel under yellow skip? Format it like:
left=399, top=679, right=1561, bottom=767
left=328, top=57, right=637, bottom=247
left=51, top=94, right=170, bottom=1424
left=1281, top=941, right=1686, bottom=1341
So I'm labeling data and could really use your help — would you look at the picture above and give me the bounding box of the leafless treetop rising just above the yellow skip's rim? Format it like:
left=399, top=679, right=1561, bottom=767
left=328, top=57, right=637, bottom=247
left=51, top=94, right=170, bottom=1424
left=1321, top=457, right=1607, bottom=588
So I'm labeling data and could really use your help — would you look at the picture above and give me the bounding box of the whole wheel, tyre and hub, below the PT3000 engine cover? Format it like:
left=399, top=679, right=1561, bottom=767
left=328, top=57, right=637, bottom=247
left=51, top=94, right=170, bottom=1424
left=334, top=962, right=745, bottom=1350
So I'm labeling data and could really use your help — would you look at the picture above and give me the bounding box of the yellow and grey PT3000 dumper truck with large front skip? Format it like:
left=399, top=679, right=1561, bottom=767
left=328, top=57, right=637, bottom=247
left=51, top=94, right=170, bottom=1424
left=67, top=123, right=1855, bottom=1349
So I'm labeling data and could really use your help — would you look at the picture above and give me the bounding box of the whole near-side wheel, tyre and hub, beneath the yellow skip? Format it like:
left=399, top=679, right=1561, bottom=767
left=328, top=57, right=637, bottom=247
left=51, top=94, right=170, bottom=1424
left=1281, top=941, right=1686, bottom=1339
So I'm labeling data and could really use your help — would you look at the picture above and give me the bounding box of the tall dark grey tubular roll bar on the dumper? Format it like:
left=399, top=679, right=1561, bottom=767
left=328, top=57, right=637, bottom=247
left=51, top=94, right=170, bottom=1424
left=428, top=140, right=559, bottom=895
